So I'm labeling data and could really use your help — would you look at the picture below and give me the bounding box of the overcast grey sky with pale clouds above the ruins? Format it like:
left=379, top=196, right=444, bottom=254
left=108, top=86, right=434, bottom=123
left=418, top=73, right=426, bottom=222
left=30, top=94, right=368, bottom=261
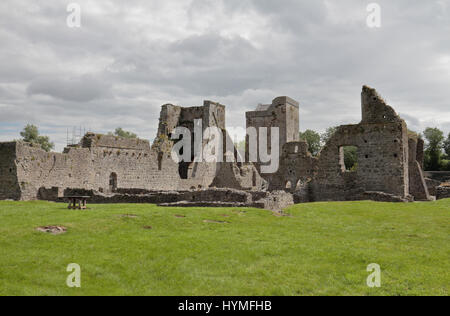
left=0, top=0, right=450, bottom=150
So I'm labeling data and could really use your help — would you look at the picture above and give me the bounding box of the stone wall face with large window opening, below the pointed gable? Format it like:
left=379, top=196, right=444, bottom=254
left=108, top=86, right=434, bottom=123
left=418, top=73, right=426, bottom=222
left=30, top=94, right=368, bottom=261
left=313, top=122, right=409, bottom=201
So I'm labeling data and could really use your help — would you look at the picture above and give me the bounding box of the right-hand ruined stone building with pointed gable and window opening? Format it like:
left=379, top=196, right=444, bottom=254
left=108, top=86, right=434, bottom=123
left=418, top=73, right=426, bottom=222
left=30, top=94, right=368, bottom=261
left=269, top=86, right=430, bottom=202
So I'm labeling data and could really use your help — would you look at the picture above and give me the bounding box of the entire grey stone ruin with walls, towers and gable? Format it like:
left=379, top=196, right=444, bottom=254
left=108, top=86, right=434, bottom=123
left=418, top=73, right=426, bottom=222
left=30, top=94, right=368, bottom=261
left=0, top=86, right=449, bottom=211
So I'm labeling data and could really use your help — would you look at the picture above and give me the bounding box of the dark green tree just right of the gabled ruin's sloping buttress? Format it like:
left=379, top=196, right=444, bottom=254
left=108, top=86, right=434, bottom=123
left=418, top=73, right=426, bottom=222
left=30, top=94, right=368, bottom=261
left=423, top=127, right=444, bottom=171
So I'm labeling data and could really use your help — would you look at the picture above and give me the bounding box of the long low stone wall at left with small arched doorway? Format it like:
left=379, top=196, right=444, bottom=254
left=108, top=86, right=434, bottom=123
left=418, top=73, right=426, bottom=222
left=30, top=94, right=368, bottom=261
left=7, top=136, right=179, bottom=200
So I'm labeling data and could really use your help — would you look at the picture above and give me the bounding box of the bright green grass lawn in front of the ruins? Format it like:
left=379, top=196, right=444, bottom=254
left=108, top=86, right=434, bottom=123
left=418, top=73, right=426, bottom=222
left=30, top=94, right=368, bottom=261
left=0, top=200, right=450, bottom=295
